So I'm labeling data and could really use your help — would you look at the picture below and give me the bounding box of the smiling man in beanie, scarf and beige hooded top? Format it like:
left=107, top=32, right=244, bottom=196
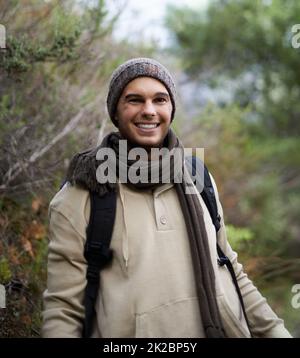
left=42, top=58, right=290, bottom=337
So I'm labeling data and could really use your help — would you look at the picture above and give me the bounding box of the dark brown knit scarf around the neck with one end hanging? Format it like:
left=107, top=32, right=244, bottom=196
left=66, top=129, right=226, bottom=338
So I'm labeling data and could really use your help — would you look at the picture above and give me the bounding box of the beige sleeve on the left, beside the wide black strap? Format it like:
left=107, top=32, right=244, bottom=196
left=41, top=196, right=86, bottom=338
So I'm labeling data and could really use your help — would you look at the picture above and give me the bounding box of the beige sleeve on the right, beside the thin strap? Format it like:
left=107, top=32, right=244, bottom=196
left=211, top=177, right=292, bottom=338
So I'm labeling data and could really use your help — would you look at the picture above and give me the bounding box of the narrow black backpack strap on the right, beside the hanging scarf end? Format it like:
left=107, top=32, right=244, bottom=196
left=186, top=156, right=252, bottom=335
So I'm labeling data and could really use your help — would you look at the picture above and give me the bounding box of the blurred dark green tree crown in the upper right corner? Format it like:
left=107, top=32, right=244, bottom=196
left=166, top=0, right=300, bottom=137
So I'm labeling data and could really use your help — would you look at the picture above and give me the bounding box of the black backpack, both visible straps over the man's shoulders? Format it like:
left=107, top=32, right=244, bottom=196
left=83, top=156, right=251, bottom=338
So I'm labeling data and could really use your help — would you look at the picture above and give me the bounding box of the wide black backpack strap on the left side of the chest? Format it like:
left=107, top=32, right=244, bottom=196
left=83, top=192, right=117, bottom=338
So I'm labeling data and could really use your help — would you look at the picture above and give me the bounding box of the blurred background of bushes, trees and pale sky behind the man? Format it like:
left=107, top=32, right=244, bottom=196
left=0, top=0, right=300, bottom=337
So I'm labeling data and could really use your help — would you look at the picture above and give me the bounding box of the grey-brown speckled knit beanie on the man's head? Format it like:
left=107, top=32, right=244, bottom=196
left=106, top=57, right=176, bottom=127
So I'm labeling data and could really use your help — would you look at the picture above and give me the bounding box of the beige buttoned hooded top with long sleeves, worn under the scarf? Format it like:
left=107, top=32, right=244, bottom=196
left=42, top=177, right=290, bottom=338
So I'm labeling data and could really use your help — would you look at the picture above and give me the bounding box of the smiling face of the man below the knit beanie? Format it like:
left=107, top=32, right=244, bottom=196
left=116, top=77, right=172, bottom=149
